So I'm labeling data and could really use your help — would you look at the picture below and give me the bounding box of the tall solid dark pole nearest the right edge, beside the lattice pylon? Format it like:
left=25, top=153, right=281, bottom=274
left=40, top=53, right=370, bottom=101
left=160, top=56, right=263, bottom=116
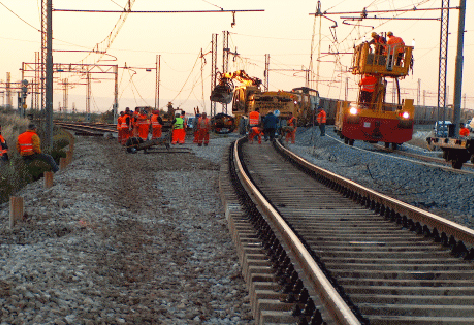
left=453, top=0, right=466, bottom=135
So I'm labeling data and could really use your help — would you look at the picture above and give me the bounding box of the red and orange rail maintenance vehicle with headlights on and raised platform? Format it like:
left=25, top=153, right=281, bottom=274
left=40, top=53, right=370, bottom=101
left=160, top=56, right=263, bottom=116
left=335, top=42, right=415, bottom=149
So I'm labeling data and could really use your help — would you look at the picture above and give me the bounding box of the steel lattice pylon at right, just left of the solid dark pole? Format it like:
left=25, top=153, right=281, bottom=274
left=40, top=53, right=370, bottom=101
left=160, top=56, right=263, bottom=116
left=438, top=0, right=449, bottom=121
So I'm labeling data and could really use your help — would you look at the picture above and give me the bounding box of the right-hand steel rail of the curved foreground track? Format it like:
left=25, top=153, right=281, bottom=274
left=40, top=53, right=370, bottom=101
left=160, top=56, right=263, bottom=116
left=276, top=141, right=474, bottom=246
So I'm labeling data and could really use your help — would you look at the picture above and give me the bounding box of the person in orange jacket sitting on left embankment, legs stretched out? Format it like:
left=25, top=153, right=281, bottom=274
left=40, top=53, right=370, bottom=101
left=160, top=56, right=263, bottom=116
left=16, top=124, right=59, bottom=172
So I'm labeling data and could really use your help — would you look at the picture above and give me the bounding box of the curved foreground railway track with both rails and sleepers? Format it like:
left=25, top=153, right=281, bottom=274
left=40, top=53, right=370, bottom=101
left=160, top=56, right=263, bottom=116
left=221, top=137, right=474, bottom=325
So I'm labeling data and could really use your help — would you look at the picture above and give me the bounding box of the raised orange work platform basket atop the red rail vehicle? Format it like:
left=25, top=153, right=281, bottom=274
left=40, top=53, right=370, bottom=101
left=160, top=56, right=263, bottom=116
left=351, top=42, right=413, bottom=77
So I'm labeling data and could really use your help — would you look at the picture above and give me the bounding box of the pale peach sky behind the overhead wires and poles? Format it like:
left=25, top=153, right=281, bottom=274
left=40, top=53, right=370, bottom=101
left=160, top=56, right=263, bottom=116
left=0, top=0, right=474, bottom=112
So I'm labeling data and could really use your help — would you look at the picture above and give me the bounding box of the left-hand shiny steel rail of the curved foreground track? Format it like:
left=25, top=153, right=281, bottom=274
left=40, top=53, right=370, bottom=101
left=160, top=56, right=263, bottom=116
left=234, top=138, right=361, bottom=325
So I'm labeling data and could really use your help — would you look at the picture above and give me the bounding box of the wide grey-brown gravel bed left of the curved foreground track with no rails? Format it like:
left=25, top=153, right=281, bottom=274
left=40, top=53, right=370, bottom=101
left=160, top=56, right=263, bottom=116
left=0, top=136, right=254, bottom=325
